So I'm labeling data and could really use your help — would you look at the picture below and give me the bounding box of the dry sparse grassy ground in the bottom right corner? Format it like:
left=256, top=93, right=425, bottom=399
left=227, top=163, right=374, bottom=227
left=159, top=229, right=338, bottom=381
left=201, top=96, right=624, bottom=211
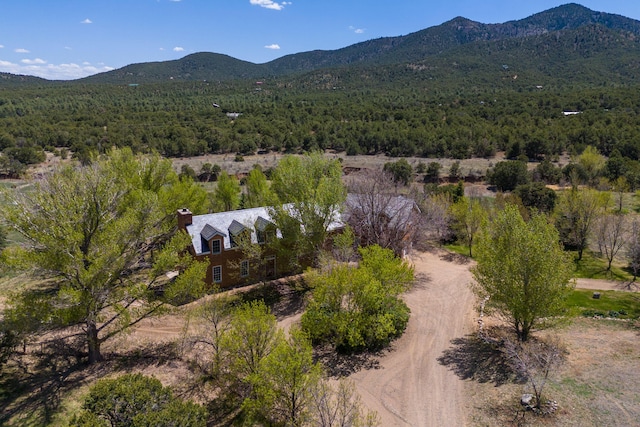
left=468, top=318, right=640, bottom=427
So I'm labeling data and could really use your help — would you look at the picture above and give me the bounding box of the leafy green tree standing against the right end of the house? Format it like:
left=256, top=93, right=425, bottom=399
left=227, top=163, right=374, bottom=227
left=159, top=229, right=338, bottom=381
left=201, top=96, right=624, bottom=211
left=269, top=153, right=346, bottom=270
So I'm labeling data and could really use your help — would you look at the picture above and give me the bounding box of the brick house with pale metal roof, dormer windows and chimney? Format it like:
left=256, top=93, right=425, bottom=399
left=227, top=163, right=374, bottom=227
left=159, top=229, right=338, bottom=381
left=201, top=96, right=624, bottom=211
left=178, top=205, right=343, bottom=288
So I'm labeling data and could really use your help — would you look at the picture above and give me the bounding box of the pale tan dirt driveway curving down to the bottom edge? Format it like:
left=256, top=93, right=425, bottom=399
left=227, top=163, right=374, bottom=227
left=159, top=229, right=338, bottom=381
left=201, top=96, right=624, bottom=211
left=351, top=253, right=474, bottom=427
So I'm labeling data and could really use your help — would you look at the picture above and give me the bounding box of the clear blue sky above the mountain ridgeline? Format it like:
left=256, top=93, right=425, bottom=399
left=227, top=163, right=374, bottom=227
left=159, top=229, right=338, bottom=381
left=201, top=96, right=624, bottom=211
left=0, top=0, right=640, bottom=80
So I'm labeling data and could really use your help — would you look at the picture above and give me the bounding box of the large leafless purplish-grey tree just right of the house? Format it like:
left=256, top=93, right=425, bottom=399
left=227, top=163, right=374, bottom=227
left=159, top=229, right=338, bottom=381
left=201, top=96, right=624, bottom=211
left=345, top=170, right=422, bottom=255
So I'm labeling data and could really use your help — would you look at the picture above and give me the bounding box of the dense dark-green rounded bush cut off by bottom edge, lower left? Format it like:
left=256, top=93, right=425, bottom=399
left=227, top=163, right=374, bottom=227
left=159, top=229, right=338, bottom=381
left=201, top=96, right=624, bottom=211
left=70, top=374, right=207, bottom=427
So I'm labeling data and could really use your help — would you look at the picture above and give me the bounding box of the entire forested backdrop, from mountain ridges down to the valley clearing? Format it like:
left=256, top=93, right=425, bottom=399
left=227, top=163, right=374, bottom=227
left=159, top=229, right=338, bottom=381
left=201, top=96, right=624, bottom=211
left=0, top=4, right=640, bottom=176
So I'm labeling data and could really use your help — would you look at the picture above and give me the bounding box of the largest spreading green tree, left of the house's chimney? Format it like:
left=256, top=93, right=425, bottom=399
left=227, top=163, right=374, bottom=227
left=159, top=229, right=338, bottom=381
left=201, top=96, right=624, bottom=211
left=3, top=150, right=206, bottom=363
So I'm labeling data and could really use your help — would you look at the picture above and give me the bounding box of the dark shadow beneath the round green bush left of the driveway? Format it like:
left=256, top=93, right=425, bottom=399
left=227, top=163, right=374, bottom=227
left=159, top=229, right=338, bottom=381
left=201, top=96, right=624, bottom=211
left=314, top=345, right=387, bottom=378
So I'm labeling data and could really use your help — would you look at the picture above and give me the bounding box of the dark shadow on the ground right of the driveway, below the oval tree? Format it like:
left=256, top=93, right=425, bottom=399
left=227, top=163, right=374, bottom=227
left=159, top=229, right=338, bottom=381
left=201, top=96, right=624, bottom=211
left=438, top=335, right=517, bottom=387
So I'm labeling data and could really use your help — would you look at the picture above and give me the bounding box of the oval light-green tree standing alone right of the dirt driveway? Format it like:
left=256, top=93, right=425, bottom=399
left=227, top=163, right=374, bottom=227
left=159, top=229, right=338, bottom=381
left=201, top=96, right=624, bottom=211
left=472, top=205, right=573, bottom=341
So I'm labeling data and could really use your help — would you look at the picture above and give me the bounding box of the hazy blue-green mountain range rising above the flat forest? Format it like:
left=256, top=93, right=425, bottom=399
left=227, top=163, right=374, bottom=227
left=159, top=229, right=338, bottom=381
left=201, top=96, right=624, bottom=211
left=0, top=3, right=640, bottom=88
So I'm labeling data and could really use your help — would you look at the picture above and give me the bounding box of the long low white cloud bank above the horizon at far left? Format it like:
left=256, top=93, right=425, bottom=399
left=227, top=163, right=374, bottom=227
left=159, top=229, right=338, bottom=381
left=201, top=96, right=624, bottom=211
left=0, top=59, right=114, bottom=80
